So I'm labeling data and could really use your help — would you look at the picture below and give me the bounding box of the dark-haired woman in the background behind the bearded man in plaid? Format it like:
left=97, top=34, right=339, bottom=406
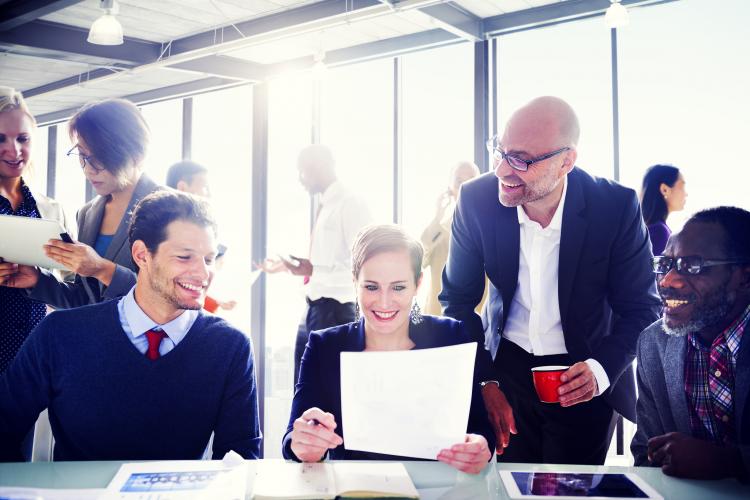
left=641, top=165, right=687, bottom=255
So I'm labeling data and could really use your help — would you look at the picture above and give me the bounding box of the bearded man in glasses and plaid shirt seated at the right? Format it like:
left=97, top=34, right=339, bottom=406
left=631, top=207, right=750, bottom=479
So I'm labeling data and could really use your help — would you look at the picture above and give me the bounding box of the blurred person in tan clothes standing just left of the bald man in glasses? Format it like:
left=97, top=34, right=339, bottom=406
left=421, top=161, right=484, bottom=316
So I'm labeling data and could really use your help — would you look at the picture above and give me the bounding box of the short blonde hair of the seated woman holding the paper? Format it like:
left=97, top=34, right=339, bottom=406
left=352, top=224, right=424, bottom=283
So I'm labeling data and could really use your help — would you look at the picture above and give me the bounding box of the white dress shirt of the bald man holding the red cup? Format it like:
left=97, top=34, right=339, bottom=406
left=503, top=178, right=609, bottom=395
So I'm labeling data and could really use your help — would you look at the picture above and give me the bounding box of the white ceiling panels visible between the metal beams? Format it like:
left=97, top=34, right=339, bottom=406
left=0, top=0, right=564, bottom=119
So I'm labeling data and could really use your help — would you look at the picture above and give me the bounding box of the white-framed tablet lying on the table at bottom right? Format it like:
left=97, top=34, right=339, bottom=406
left=500, top=470, right=664, bottom=500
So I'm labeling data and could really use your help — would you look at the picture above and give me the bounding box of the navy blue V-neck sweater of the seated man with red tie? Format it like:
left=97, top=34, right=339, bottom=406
left=0, top=300, right=261, bottom=461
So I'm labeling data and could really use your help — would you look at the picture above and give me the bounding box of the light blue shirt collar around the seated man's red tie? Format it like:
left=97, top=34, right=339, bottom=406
left=117, top=287, right=200, bottom=356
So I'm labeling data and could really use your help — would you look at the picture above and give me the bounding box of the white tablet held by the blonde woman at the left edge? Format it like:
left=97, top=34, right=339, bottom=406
left=0, top=215, right=70, bottom=269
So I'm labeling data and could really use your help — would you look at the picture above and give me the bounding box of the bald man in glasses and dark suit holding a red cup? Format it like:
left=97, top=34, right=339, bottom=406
left=440, top=97, right=659, bottom=464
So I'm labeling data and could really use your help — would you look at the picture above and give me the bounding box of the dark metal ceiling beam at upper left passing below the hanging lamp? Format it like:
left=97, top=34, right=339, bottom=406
left=0, top=21, right=162, bottom=64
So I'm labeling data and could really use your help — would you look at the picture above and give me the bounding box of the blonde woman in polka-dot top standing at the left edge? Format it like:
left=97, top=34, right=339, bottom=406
left=0, top=87, right=70, bottom=373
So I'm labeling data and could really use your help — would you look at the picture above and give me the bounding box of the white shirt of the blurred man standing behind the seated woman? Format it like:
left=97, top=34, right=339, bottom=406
left=306, top=181, right=372, bottom=304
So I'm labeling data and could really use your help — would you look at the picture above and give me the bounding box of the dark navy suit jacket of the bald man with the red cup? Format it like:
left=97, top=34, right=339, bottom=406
left=440, top=168, right=660, bottom=421
